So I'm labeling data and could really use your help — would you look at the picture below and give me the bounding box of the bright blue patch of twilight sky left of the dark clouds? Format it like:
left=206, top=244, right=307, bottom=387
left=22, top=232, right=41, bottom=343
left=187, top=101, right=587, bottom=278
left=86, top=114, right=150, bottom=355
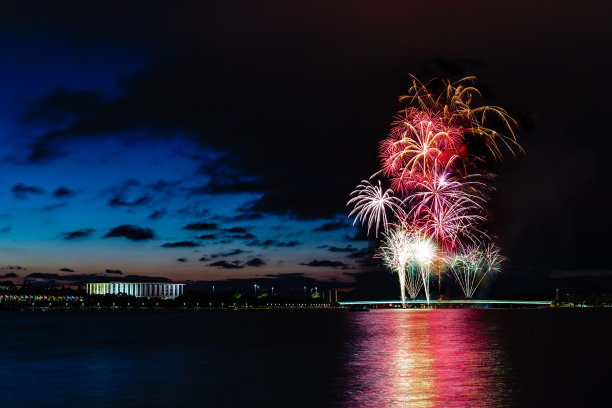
left=0, top=29, right=367, bottom=286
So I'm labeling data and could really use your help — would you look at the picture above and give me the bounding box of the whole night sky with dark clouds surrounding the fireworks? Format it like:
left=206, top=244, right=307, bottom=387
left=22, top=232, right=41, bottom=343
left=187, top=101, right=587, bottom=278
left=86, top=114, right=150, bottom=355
left=0, top=1, right=612, bottom=296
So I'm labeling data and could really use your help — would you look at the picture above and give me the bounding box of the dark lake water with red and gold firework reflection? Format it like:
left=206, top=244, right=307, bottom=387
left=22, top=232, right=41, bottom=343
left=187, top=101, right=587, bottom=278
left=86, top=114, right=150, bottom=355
left=0, top=309, right=612, bottom=407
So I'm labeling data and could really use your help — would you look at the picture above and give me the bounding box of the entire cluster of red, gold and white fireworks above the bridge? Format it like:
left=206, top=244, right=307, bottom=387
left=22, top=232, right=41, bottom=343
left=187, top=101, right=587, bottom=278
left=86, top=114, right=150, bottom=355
left=347, top=76, right=522, bottom=303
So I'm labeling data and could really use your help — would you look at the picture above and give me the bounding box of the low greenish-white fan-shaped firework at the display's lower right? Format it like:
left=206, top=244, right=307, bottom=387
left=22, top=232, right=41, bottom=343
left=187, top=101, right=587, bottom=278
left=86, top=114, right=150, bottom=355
left=446, top=244, right=506, bottom=299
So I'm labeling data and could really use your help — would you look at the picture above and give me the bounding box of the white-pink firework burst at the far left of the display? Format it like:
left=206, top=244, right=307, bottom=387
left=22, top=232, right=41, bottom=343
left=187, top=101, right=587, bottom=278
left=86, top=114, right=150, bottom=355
left=346, top=180, right=405, bottom=237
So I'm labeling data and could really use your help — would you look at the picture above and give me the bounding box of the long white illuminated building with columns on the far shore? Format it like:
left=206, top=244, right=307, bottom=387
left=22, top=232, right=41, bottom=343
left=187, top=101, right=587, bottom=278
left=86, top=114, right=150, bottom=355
left=87, top=282, right=185, bottom=298
